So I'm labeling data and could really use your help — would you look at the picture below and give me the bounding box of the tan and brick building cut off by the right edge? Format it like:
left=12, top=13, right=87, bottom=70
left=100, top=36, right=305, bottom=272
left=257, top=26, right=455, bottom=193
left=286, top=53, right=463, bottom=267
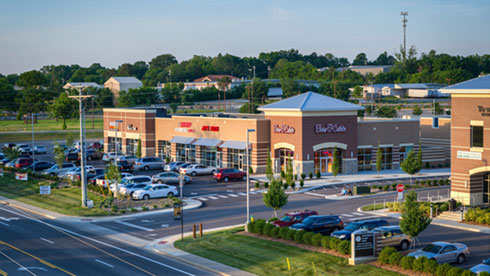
left=443, top=75, right=490, bottom=205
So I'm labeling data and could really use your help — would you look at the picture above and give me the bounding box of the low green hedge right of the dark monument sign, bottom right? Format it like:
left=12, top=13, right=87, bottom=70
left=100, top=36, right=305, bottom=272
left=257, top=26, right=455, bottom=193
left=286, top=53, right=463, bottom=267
left=378, top=247, right=482, bottom=276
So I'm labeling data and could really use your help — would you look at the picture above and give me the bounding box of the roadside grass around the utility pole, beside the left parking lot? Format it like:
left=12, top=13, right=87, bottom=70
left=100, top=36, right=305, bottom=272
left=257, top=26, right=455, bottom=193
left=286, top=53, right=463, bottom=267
left=0, top=172, right=109, bottom=216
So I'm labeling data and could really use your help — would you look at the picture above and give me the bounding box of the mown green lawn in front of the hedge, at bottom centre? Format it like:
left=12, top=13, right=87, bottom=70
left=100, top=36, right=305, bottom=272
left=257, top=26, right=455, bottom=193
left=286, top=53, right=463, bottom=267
left=175, top=228, right=400, bottom=276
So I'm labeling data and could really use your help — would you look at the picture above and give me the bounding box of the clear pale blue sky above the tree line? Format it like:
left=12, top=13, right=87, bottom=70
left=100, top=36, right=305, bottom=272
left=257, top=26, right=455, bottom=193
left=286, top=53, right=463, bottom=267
left=0, top=0, right=490, bottom=75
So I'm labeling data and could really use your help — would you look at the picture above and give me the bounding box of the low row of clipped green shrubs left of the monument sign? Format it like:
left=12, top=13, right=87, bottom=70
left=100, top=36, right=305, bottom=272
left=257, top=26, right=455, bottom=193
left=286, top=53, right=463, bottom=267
left=248, top=219, right=351, bottom=255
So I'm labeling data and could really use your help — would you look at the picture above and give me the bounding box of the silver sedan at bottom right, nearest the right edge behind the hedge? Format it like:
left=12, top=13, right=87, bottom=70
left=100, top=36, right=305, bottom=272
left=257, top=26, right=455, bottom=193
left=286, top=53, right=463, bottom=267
left=408, top=242, right=470, bottom=264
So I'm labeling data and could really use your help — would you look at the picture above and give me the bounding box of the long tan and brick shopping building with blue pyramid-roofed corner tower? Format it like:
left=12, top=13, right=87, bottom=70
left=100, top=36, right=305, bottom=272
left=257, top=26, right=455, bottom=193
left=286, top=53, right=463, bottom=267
left=104, top=92, right=448, bottom=175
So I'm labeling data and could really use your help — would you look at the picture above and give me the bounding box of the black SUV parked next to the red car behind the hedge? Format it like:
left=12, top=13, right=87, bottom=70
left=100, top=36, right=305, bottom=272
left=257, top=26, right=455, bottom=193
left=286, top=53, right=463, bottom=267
left=289, top=216, right=344, bottom=235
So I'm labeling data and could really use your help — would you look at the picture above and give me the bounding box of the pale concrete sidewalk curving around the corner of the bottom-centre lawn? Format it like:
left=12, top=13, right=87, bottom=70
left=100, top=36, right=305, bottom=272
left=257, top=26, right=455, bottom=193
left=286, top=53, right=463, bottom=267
left=151, top=224, right=254, bottom=276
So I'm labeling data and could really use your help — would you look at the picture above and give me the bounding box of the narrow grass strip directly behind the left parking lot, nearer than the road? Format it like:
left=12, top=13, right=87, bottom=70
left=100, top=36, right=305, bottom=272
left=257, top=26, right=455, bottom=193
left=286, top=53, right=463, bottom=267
left=0, top=130, right=104, bottom=143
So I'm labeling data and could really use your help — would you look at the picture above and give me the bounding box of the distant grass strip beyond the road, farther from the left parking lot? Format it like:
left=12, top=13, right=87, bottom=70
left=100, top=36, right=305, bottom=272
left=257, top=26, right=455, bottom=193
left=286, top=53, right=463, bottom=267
left=0, top=118, right=104, bottom=132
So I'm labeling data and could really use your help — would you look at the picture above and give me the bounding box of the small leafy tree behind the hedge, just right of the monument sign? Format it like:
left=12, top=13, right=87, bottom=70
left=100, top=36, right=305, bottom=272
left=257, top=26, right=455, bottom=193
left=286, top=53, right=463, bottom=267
left=400, top=191, right=432, bottom=247
